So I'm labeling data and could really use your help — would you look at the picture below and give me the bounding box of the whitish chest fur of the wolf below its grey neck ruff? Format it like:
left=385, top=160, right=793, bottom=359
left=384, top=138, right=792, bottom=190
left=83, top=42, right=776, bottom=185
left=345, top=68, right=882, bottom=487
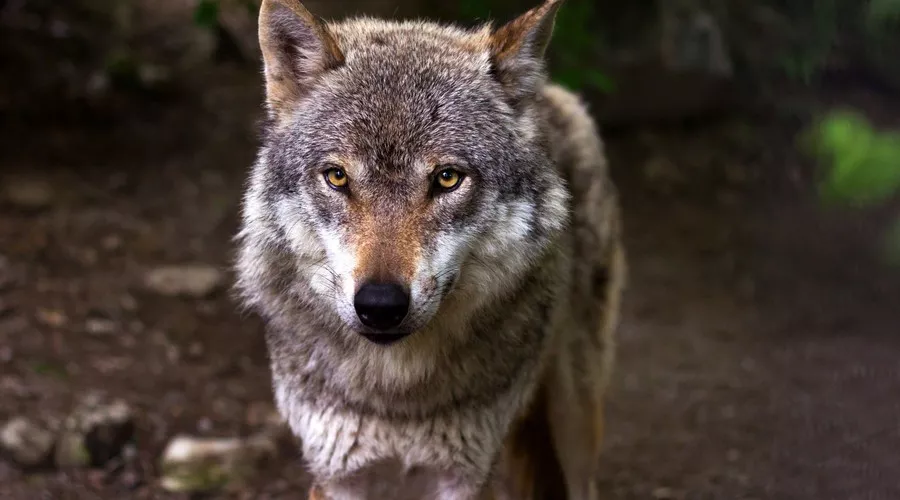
left=275, top=380, right=527, bottom=500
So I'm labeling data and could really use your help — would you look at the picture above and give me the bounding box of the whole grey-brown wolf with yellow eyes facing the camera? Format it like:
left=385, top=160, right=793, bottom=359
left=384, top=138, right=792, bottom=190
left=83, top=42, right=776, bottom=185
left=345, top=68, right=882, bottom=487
left=235, top=0, right=626, bottom=500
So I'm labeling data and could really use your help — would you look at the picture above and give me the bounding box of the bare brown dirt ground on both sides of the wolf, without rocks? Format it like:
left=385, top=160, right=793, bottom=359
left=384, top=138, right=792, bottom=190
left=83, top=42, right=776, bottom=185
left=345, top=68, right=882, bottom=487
left=0, top=58, right=900, bottom=500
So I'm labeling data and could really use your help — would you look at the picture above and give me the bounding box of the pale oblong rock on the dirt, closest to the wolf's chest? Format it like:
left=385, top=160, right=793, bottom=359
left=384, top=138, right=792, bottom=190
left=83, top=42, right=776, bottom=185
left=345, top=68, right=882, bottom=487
left=161, top=436, right=277, bottom=492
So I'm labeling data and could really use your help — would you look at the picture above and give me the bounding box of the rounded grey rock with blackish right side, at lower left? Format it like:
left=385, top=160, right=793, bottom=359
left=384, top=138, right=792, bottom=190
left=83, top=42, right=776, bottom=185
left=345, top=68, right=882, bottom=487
left=56, top=395, right=134, bottom=467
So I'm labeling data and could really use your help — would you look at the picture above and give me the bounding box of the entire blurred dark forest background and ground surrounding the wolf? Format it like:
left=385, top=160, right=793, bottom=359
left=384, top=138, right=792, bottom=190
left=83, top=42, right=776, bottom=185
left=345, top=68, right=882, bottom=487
left=0, top=0, right=900, bottom=500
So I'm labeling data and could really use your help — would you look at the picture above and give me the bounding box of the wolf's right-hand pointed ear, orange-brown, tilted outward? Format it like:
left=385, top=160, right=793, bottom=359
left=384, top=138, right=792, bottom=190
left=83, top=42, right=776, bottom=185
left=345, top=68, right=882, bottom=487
left=491, top=0, right=563, bottom=101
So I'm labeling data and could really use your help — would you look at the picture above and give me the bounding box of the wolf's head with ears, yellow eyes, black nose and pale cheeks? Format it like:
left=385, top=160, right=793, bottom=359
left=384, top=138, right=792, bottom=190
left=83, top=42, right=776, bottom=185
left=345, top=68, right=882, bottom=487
left=238, top=0, right=567, bottom=344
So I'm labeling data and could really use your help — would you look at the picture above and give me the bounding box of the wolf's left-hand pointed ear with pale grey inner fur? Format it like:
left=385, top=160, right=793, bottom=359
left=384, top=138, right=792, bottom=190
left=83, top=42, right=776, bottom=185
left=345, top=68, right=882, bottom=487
left=259, top=0, right=344, bottom=118
